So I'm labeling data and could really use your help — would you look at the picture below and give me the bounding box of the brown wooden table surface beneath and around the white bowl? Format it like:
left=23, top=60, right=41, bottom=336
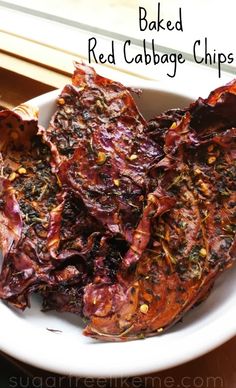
left=0, top=69, right=236, bottom=388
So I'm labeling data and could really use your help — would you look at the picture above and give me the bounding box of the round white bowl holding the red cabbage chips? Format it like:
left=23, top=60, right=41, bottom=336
left=0, top=82, right=236, bottom=378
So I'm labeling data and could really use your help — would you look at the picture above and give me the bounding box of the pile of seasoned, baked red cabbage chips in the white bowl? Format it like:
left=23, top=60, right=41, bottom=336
left=0, top=63, right=236, bottom=341
